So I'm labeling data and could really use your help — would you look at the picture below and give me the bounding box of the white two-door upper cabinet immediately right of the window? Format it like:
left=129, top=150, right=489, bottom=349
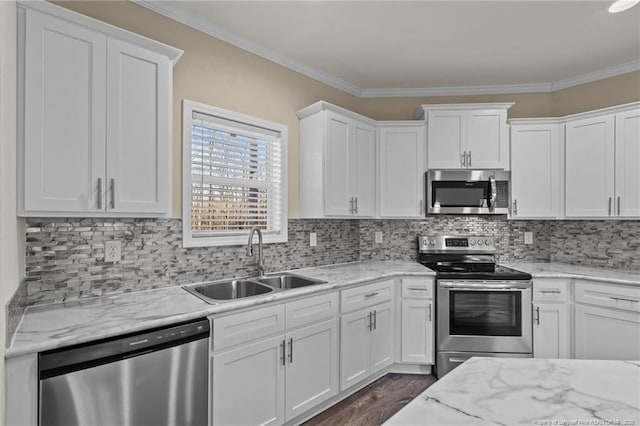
left=297, top=101, right=376, bottom=218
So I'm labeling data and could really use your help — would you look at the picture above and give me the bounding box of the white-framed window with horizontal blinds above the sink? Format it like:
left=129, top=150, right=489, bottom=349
left=182, top=100, right=287, bottom=247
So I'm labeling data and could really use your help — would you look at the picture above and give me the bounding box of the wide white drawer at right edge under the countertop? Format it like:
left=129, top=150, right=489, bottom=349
left=575, top=280, right=640, bottom=312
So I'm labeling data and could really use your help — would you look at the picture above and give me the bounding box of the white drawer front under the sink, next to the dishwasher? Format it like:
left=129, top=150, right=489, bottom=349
left=212, top=305, right=285, bottom=351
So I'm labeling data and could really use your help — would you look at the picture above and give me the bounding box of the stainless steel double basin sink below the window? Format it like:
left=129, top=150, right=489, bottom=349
left=182, top=272, right=326, bottom=304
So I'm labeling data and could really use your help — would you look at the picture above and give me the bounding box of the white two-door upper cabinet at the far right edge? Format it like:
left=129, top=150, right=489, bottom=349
left=565, top=104, right=640, bottom=218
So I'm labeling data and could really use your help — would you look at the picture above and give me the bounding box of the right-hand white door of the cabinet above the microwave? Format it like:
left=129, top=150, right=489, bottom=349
left=466, top=110, right=509, bottom=169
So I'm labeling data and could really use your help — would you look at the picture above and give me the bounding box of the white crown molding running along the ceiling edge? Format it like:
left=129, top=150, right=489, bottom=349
left=131, top=0, right=640, bottom=98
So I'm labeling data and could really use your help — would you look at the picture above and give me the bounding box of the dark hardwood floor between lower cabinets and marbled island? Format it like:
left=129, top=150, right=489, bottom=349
left=302, top=373, right=436, bottom=426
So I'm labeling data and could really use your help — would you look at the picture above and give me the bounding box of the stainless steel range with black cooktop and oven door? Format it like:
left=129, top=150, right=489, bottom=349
left=418, top=235, right=533, bottom=377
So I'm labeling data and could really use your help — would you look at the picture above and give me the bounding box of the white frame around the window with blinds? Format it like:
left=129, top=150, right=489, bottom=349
left=182, top=99, right=289, bottom=247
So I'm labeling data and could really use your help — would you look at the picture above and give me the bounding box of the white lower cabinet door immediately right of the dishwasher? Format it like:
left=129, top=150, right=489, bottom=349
left=211, top=336, right=286, bottom=425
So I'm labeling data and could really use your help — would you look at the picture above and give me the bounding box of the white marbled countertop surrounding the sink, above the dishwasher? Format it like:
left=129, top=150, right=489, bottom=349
left=5, top=262, right=434, bottom=358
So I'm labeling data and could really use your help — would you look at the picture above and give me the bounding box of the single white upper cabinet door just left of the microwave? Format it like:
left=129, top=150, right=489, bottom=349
left=379, top=123, right=425, bottom=218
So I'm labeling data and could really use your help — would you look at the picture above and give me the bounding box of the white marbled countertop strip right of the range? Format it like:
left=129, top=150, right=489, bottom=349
left=500, top=262, right=640, bottom=285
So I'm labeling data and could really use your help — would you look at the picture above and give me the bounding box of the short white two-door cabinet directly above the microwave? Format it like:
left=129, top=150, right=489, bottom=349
left=417, top=103, right=513, bottom=169
